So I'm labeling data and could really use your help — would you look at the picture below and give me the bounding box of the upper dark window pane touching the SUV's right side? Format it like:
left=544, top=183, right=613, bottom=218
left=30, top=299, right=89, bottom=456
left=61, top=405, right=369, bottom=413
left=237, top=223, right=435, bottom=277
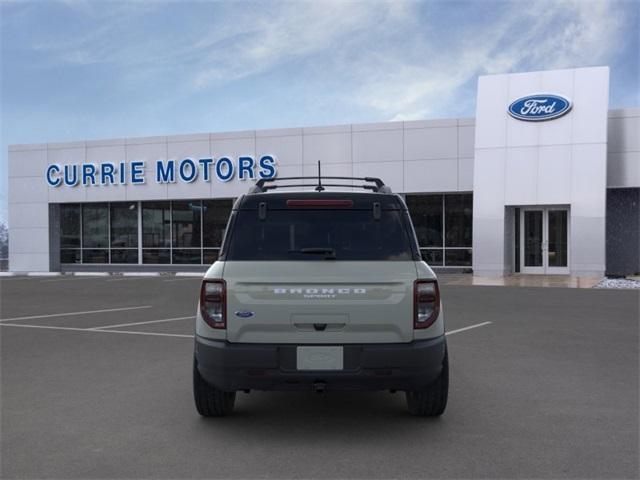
left=405, top=195, right=443, bottom=247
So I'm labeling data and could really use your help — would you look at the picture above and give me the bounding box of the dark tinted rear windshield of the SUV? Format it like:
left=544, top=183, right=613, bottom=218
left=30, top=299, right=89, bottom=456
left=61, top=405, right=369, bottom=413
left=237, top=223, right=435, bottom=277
left=225, top=209, right=413, bottom=261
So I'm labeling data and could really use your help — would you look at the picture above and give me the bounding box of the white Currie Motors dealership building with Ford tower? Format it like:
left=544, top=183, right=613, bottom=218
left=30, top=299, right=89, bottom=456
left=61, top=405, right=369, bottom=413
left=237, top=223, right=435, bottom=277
left=9, top=67, right=640, bottom=276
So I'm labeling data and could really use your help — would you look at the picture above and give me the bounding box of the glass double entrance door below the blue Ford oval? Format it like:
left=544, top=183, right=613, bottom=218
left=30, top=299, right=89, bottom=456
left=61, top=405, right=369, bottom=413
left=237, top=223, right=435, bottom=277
left=519, top=207, right=569, bottom=274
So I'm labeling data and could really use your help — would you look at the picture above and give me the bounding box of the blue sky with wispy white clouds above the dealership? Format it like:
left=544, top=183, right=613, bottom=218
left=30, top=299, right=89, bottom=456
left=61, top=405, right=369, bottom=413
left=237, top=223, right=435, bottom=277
left=0, top=0, right=640, bottom=225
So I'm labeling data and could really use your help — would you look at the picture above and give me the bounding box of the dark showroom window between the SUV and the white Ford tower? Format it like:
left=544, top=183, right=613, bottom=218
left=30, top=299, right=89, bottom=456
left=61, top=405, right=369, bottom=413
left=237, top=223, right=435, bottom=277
left=405, top=193, right=473, bottom=267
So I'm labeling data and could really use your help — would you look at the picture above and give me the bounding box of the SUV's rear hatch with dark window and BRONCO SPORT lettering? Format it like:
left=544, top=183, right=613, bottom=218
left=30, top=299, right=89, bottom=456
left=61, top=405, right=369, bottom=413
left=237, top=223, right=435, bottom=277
left=222, top=193, right=419, bottom=344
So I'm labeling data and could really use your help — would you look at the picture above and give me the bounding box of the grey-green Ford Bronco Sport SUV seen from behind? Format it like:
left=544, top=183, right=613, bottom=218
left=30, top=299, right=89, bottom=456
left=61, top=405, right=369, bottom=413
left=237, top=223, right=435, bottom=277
left=193, top=176, right=449, bottom=416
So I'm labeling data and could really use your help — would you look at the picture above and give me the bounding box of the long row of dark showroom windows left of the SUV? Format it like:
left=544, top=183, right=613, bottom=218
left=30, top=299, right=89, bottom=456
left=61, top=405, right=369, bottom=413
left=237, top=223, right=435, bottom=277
left=60, top=199, right=233, bottom=265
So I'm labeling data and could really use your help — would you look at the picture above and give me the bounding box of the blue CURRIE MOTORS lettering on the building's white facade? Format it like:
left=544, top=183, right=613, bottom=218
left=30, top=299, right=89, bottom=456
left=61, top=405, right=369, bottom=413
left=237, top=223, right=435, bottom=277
left=45, top=155, right=277, bottom=187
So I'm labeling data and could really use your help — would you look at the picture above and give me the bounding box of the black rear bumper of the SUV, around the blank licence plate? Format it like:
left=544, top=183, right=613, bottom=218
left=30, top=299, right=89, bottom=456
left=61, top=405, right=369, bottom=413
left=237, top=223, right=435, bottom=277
left=195, top=335, right=446, bottom=391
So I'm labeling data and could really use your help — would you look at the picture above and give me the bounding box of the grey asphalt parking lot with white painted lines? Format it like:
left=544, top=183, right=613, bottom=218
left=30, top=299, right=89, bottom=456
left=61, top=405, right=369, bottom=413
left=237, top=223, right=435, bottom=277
left=0, top=277, right=640, bottom=478
